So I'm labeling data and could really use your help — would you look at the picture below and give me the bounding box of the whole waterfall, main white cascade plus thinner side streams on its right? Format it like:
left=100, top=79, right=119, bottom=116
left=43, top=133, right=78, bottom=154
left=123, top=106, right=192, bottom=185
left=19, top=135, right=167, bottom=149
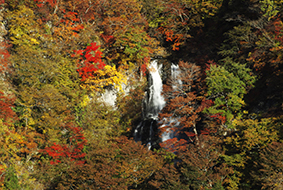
left=134, top=60, right=182, bottom=149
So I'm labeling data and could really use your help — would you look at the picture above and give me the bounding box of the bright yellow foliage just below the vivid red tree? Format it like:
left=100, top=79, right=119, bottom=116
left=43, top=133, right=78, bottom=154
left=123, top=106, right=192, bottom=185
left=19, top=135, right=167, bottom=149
left=81, top=65, right=127, bottom=92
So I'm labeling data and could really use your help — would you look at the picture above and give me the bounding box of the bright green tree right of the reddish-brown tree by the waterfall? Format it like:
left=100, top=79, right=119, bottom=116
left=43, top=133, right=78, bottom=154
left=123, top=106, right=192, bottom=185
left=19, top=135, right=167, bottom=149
left=204, top=58, right=255, bottom=127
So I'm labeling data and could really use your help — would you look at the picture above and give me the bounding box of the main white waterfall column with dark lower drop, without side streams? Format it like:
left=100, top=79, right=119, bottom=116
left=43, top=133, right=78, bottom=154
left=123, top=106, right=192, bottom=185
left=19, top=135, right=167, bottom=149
left=134, top=60, right=166, bottom=149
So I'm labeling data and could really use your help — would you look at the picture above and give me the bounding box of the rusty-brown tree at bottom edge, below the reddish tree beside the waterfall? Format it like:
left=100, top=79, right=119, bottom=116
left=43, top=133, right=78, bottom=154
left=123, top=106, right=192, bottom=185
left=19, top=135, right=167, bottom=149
left=177, top=135, right=233, bottom=189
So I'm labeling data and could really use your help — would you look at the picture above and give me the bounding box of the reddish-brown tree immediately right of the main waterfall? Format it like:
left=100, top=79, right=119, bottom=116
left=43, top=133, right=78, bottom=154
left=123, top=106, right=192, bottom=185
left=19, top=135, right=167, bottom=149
left=159, top=61, right=204, bottom=149
